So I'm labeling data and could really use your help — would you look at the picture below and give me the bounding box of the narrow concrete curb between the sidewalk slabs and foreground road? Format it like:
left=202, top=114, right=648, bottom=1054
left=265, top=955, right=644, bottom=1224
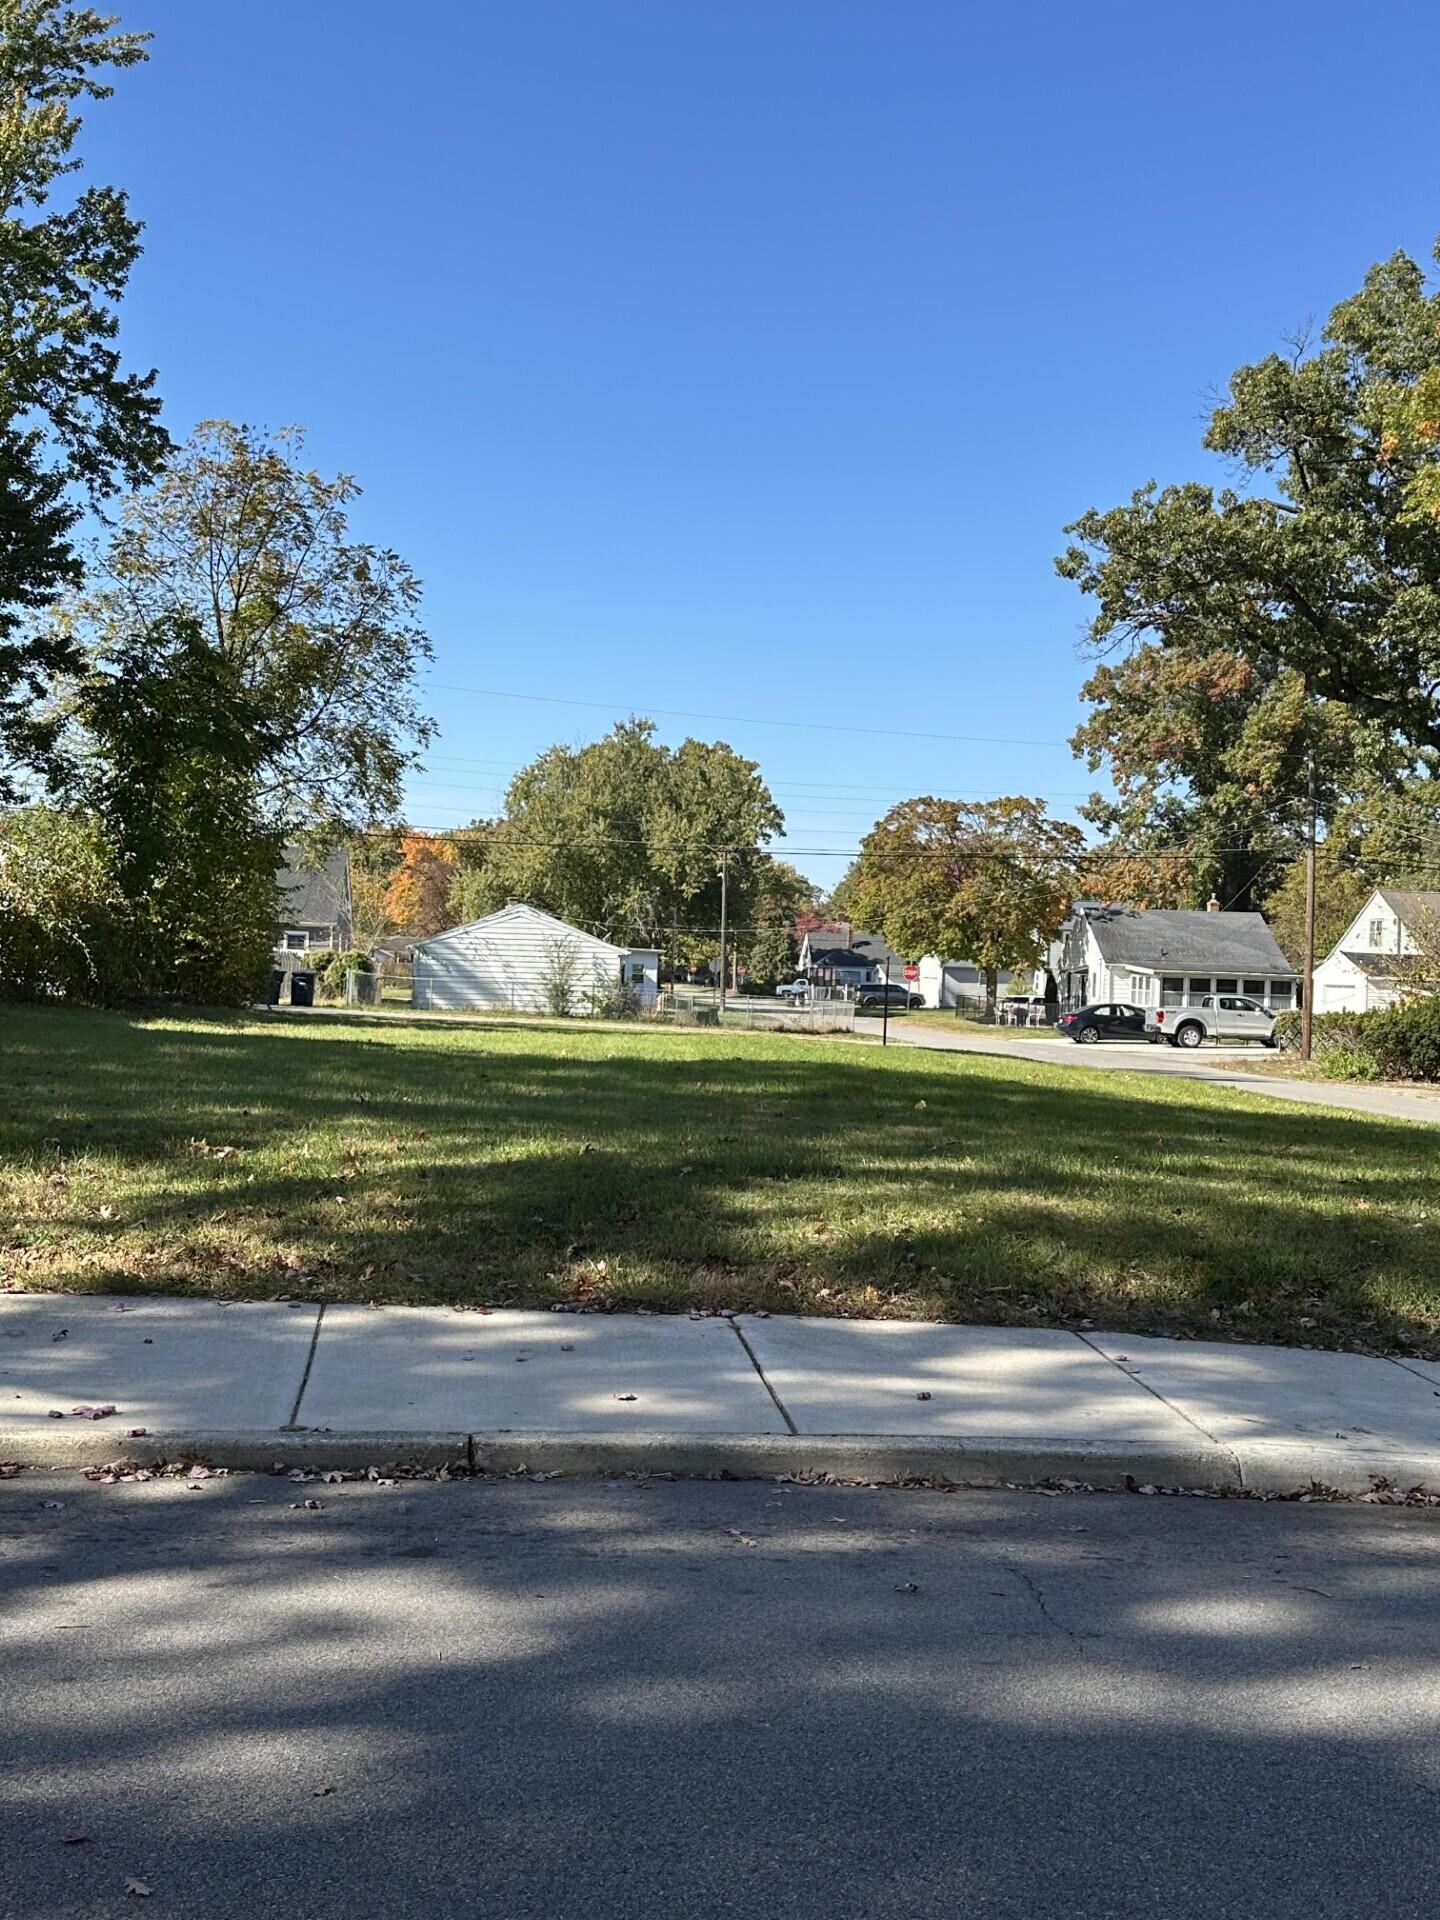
left=0, top=1427, right=1440, bottom=1496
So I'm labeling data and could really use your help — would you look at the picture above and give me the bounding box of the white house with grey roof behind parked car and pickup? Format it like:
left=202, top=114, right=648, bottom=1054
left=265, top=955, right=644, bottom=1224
left=1056, top=900, right=1300, bottom=1012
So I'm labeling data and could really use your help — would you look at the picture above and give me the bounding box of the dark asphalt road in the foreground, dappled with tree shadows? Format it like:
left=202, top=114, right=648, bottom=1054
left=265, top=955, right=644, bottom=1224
left=0, top=1473, right=1440, bottom=1920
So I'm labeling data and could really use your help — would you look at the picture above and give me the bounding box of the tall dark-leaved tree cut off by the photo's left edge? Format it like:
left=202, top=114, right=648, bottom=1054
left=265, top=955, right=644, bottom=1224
left=0, top=0, right=169, bottom=799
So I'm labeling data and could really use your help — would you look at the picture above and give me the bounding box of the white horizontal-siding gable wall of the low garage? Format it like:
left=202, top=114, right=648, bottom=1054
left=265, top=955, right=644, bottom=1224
left=413, top=906, right=645, bottom=1014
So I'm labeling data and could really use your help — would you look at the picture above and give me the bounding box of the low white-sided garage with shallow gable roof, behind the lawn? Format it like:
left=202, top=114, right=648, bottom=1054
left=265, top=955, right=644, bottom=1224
left=411, top=902, right=660, bottom=1014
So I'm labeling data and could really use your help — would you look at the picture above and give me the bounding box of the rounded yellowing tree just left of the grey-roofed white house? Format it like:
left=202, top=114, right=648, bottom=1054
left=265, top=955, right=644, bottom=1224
left=852, top=795, right=1085, bottom=1006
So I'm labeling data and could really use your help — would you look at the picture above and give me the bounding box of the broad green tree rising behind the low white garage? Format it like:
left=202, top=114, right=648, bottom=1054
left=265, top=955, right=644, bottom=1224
left=467, top=718, right=783, bottom=962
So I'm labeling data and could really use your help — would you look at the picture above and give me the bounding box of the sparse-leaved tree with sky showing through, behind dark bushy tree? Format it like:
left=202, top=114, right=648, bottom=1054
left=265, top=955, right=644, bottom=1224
left=54, top=420, right=434, bottom=839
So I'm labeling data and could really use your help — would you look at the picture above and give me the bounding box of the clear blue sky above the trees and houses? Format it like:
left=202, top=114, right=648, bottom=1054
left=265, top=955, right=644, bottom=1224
left=84, top=0, right=1440, bottom=881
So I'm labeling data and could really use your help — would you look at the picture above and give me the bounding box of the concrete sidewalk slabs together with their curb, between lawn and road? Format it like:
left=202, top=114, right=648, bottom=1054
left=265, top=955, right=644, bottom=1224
left=0, top=1294, right=1440, bottom=1492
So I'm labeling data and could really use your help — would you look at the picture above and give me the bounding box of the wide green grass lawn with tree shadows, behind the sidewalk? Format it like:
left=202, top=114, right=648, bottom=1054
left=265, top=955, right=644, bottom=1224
left=0, top=1008, right=1440, bottom=1356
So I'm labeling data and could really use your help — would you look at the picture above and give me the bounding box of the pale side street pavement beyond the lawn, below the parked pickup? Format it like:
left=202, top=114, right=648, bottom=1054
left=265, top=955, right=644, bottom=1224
left=866, top=1020, right=1440, bottom=1125
